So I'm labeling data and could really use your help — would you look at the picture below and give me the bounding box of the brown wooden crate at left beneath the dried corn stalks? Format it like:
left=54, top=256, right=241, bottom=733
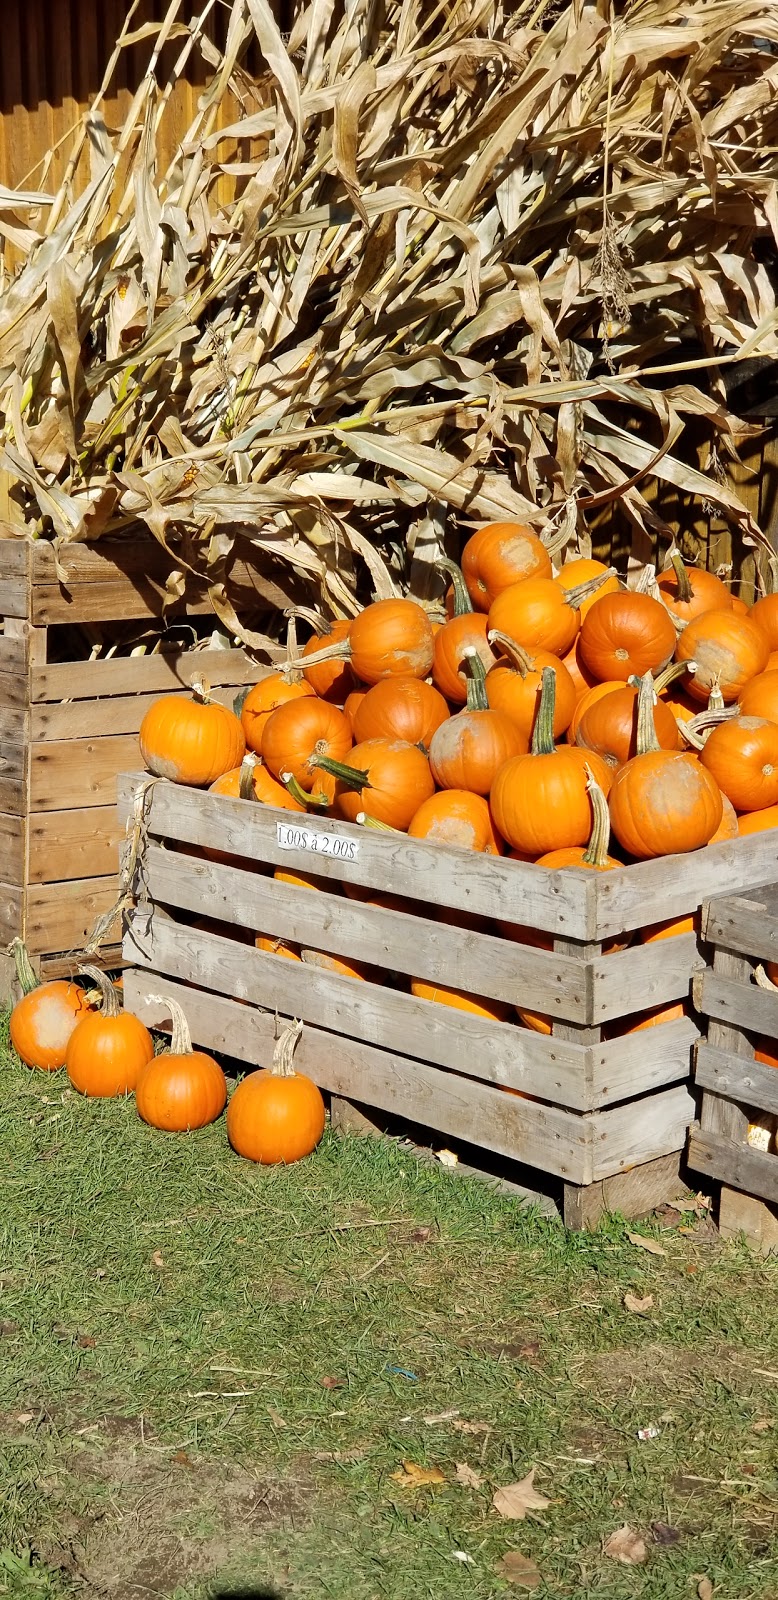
left=0, top=536, right=267, bottom=997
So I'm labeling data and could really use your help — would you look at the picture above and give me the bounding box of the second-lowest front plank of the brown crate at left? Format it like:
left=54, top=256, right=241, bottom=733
left=29, top=805, right=125, bottom=883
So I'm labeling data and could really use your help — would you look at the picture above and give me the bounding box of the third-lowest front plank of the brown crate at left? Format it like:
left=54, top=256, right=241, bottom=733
left=30, top=734, right=141, bottom=811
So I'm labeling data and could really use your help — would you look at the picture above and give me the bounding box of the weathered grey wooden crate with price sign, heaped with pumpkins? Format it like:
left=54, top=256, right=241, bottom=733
left=120, top=778, right=775, bottom=1226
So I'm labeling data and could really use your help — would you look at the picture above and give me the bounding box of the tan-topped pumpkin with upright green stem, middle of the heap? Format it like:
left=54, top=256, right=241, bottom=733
left=429, top=650, right=525, bottom=795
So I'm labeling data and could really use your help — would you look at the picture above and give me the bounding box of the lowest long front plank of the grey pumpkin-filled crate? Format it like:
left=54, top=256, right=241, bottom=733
left=125, top=957, right=589, bottom=1181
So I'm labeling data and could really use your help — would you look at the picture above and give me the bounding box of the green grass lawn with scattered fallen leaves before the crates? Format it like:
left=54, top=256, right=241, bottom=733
left=0, top=1011, right=778, bottom=1600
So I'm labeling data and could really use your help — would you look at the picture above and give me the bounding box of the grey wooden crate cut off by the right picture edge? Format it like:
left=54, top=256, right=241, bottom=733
left=688, top=886, right=778, bottom=1250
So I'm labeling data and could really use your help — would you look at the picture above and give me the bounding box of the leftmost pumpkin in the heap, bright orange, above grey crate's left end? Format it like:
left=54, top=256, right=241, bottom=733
left=139, top=680, right=247, bottom=789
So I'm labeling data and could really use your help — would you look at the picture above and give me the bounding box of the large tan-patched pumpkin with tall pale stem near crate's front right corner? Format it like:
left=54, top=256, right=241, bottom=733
left=610, top=668, right=725, bottom=861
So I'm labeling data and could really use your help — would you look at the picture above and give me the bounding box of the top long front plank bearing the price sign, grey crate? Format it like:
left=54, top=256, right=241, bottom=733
left=120, top=774, right=595, bottom=938
